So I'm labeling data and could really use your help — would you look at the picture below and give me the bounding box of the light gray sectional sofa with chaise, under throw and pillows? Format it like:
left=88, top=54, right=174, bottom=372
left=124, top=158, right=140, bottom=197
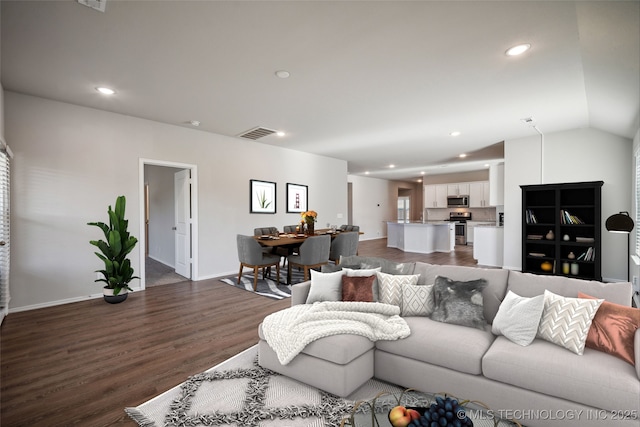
left=259, top=256, right=640, bottom=427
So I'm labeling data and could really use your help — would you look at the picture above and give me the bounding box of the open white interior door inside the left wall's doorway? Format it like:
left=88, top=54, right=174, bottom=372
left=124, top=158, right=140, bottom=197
left=173, top=169, right=191, bottom=279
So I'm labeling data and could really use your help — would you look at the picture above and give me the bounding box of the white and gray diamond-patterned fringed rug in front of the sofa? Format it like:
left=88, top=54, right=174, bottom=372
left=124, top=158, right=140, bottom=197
left=125, top=345, right=402, bottom=427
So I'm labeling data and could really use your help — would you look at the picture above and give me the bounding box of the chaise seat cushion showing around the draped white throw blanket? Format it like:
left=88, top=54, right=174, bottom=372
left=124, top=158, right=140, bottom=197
left=258, top=323, right=374, bottom=365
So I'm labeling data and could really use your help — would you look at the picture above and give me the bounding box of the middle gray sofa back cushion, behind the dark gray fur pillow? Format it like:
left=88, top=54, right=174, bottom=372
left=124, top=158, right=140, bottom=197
left=414, top=262, right=510, bottom=323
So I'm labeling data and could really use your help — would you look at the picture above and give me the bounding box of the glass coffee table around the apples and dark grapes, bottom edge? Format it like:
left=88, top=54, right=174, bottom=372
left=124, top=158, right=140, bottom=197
left=340, top=389, right=522, bottom=427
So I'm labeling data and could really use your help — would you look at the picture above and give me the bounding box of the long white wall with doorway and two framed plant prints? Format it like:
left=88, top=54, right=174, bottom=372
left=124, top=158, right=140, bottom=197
left=5, top=92, right=347, bottom=310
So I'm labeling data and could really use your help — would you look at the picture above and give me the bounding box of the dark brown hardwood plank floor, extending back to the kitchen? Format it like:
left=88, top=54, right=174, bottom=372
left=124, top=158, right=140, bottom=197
left=0, top=239, right=476, bottom=427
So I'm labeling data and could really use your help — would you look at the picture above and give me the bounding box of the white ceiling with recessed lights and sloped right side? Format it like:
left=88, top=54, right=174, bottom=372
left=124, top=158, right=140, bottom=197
left=0, top=0, right=640, bottom=179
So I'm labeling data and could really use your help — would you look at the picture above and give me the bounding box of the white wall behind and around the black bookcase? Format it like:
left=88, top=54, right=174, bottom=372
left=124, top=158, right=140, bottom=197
left=504, top=129, right=633, bottom=280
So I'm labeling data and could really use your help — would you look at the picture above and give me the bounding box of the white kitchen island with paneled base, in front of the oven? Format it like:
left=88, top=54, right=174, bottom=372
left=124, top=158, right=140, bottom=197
left=387, top=221, right=455, bottom=254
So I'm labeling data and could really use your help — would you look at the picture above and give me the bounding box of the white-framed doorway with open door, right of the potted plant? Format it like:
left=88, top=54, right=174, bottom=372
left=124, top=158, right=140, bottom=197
left=139, top=159, right=198, bottom=289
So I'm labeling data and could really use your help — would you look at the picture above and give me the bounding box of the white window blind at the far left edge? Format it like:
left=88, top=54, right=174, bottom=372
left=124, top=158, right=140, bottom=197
left=0, top=148, right=11, bottom=317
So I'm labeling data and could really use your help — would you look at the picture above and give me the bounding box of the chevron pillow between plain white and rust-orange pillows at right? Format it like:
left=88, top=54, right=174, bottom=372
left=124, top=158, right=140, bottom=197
left=538, top=290, right=604, bottom=355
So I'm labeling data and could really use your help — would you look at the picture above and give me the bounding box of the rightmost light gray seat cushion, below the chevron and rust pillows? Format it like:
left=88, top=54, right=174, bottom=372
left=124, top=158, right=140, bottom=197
left=482, top=337, right=640, bottom=410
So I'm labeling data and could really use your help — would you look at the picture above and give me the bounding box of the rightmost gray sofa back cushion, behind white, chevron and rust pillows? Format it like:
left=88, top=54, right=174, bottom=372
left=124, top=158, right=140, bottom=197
left=508, top=271, right=632, bottom=307
